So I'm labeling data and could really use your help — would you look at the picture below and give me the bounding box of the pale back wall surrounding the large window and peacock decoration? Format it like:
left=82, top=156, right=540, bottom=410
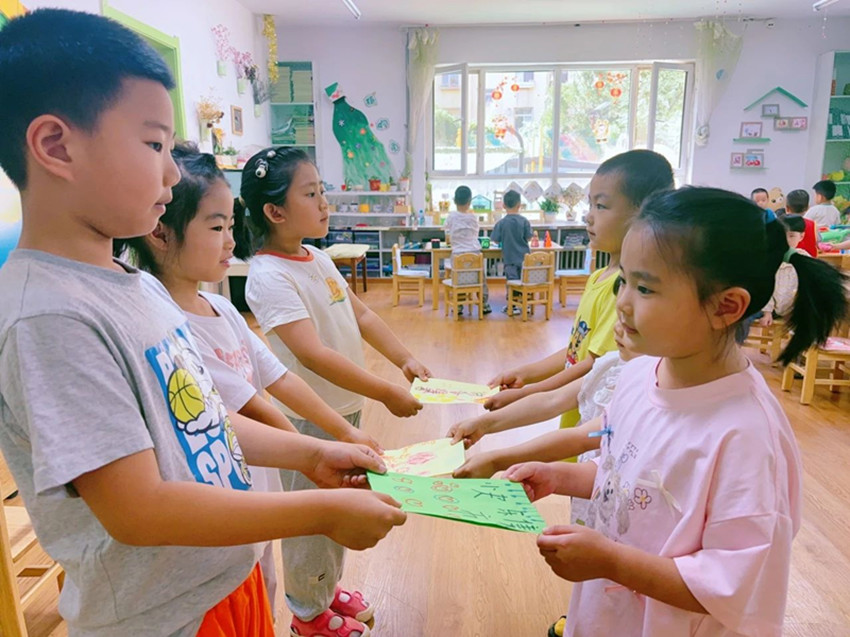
left=278, top=18, right=850, bottom=206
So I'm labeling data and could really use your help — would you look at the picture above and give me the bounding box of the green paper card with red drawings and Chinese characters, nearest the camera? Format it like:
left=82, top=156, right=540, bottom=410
left=369, top=472, right=546, bottom=533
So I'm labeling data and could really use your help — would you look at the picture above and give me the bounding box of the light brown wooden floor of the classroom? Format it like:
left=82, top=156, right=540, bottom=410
left=11, top=282, right=850, bottom=637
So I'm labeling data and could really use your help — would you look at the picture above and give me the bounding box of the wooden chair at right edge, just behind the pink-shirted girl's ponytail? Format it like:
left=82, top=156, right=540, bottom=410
left=782, top=324, right=850, bottom=405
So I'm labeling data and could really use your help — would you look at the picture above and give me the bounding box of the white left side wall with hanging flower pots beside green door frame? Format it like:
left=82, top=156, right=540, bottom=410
left=26, top=0, right=269, bottom=151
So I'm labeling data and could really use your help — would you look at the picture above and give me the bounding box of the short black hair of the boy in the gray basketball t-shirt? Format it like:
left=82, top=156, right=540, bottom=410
left=0, top=9, right=174, bottom=189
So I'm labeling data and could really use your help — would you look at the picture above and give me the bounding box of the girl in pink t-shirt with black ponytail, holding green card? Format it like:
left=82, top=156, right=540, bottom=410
left=506, top=188, right=848, bottom=637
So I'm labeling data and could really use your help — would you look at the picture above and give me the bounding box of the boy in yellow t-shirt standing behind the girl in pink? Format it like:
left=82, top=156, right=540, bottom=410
left=484, top=150, right=673, bottom=427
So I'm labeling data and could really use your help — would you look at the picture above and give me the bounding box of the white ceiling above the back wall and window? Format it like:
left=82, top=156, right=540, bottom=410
left=239, top=0, right=850, bottom=26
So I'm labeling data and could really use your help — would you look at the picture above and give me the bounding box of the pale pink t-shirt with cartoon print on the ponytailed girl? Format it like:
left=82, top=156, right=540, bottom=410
left=566, top=356, right=802, bottom=637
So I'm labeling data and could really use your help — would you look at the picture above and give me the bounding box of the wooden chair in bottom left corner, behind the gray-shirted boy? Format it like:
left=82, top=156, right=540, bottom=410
left=0, top=458, right=65, bottom=637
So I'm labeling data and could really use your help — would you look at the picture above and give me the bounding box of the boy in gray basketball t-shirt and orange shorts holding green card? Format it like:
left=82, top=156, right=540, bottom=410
left=0, top=9, right=404, bottom=637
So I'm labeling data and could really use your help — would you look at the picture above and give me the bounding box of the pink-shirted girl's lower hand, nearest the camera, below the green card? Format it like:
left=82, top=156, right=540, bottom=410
left=537, top=525, right=617, bottom=582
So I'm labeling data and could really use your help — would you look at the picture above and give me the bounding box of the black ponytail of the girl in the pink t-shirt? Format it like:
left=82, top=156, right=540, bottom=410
left=779, top=250, right=850, bottom=365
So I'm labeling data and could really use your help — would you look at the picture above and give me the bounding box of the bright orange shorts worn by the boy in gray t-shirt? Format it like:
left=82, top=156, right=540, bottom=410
left=198, top=563, right=274, bottom=637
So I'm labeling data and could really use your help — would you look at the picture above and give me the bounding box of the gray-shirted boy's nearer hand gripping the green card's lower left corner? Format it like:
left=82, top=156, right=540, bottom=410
left=323, top=489, right=407, bottom=551
